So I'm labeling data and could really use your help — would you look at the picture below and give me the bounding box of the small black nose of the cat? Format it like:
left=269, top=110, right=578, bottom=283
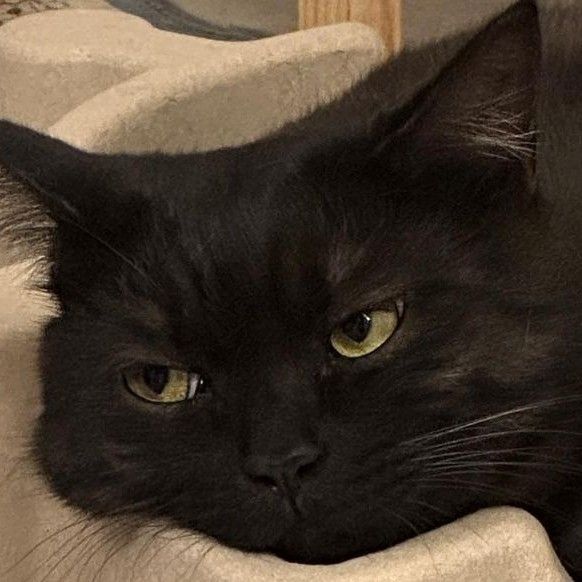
left=244, top=445, right=321, bottom=498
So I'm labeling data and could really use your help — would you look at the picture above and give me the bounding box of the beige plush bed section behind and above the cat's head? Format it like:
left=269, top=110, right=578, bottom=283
left=0, top=10, right=385, bottom=152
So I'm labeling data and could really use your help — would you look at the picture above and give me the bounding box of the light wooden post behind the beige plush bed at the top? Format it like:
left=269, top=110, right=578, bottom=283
left=299, top=0, right=402, bottom=55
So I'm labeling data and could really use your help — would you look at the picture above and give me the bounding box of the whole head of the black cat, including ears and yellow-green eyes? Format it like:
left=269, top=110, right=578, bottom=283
left=0, top=2, right=580, bottom=562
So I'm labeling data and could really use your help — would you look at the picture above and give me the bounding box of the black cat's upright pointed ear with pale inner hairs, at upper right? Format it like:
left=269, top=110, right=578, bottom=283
left=389, top=0, right=541, bottom=166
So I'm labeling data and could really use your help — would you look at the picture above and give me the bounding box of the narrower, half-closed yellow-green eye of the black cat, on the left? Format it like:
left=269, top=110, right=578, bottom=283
left=124, top=365, right=204, bottom=404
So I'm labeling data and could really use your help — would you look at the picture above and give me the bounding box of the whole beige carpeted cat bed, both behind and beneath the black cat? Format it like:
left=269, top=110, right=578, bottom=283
left=0, top=5, right=568, bottom=582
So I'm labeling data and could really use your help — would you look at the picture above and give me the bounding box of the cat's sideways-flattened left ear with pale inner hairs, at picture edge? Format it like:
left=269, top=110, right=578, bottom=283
left=0, top=121, right=155, bottom=281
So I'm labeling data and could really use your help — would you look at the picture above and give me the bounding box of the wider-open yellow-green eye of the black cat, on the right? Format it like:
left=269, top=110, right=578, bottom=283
left=330, top=305, right=400, bottom=358
